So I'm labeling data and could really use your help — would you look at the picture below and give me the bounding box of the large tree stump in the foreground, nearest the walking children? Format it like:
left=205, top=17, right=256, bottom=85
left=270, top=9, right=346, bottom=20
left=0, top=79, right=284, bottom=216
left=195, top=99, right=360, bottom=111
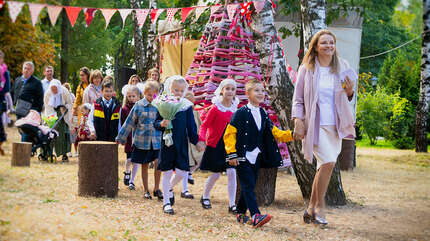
left=78, top=141, right=118, bottom=197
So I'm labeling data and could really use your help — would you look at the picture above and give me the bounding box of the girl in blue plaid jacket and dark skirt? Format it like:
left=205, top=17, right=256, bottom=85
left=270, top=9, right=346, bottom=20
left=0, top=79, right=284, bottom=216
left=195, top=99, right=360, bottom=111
left=116, top=81, right=163, bottom=200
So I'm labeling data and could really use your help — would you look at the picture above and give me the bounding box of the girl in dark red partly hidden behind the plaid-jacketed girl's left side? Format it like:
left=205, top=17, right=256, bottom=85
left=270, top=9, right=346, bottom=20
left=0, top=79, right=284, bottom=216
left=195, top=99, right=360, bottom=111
left=121, top=85, right=140, bottom=187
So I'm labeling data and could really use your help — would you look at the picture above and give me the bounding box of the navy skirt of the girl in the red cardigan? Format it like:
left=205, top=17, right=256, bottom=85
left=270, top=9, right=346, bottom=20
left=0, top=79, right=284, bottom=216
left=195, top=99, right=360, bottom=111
left=200, top=138, right=234, bottom=172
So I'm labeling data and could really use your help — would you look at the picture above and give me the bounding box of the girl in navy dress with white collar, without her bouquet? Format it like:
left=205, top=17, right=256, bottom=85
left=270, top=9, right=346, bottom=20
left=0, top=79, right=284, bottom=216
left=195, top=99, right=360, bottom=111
left=154, top=75, right=204, bottom=214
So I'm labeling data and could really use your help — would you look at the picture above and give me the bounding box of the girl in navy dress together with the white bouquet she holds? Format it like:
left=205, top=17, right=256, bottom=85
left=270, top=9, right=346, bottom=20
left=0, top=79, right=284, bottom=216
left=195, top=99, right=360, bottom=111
left=153, top=75, right=204, bottom=214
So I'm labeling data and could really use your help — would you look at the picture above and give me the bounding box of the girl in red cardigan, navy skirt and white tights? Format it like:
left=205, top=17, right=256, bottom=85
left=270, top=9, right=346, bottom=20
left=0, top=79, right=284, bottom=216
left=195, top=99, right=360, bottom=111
left=199, top=79, right=239, bottom=214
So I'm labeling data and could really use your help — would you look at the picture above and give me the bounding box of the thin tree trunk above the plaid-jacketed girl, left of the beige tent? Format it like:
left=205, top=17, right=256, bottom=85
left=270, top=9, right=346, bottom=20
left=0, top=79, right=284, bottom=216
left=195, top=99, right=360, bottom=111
left=130, top=0, right=148, bottom=78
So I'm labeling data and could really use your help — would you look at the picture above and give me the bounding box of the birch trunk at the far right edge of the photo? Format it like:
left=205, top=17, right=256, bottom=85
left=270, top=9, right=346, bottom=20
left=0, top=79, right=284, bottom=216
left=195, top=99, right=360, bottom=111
left=415, top=0, right=430, bottom=152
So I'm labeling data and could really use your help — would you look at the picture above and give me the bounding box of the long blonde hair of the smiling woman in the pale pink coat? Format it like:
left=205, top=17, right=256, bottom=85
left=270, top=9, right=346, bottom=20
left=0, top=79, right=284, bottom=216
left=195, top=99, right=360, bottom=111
left=302, top=29, right=339, bottom=73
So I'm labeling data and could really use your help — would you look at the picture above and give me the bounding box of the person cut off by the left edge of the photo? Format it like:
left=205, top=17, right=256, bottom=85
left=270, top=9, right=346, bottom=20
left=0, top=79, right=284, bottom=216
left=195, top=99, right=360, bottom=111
left=0, top=50, right=10, bottom=156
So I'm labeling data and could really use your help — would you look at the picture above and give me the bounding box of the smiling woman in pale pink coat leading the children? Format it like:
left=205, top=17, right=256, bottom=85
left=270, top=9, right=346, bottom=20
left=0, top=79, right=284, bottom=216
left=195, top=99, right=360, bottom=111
left=292, top=30, right=355, bottom=225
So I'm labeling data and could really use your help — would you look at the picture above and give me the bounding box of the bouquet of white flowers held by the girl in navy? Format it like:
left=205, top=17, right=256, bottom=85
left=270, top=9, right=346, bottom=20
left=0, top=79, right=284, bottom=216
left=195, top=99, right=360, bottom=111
left=152, top=94, right=185, bottom=146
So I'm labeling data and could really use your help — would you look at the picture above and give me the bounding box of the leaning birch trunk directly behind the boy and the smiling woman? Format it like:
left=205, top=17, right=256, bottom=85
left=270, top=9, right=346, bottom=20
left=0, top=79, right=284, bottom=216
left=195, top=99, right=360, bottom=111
left=252, top=1, right=346, bottom=205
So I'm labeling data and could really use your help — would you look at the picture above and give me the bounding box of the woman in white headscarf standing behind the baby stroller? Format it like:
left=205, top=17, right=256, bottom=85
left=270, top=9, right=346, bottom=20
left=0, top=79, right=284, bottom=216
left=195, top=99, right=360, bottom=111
left=43, top=80, right=73, bottom=162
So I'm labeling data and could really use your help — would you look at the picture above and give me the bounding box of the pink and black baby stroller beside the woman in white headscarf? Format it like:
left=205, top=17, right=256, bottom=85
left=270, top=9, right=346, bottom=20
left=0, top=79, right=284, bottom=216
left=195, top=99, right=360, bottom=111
left=15, top=106, right=68, bottom=163
